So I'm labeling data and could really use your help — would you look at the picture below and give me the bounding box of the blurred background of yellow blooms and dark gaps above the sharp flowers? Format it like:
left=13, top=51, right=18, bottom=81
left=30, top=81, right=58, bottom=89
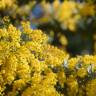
left=0, top=0, right=96, bottom=56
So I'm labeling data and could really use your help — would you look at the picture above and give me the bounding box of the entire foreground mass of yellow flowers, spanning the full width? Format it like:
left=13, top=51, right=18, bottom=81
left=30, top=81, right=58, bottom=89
left=0, top=22, right=96, bottom=96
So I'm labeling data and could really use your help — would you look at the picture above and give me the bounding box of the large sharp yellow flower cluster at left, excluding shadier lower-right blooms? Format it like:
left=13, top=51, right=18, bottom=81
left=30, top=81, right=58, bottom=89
left=0, top=22, right=68, bottom=96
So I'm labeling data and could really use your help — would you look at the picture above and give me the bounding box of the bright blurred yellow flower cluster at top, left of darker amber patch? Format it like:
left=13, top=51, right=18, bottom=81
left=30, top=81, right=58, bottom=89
left=53, top=0, right=81, bottom=31
